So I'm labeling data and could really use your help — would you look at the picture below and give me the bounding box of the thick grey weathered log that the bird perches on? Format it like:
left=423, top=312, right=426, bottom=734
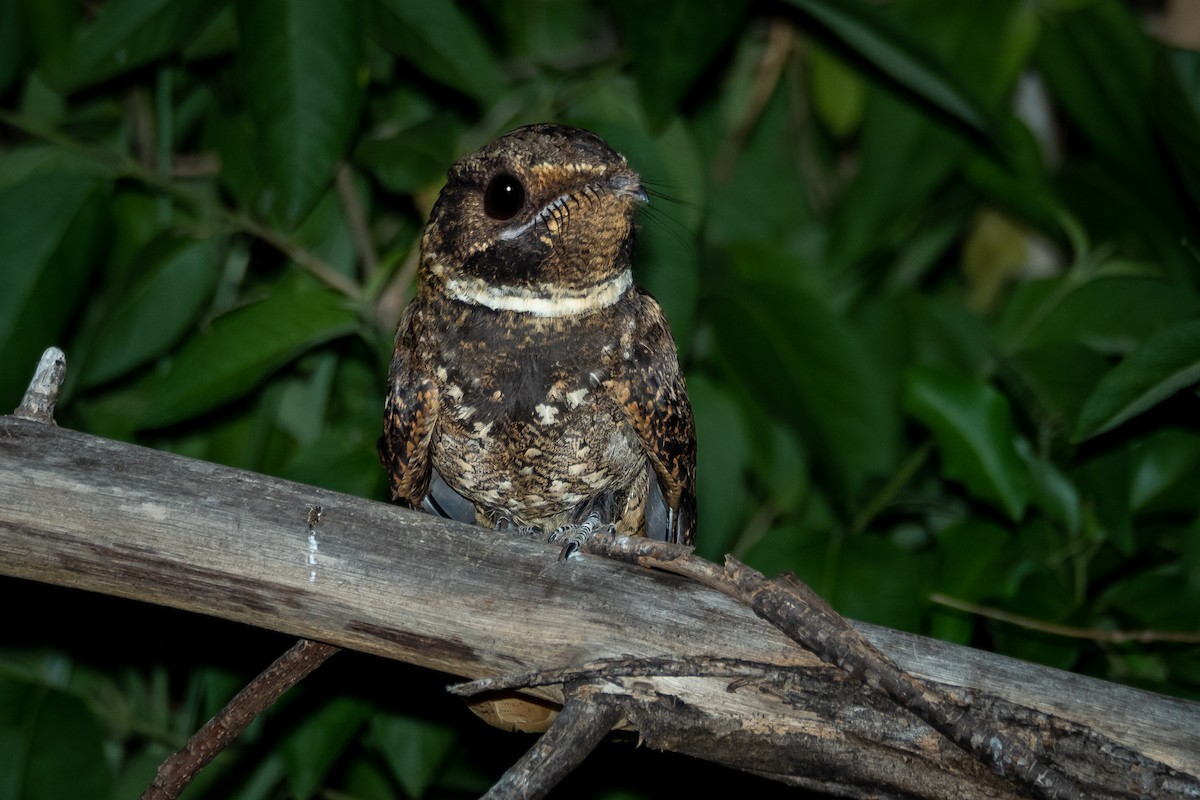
left=0, top=417, right=1200, bottom=798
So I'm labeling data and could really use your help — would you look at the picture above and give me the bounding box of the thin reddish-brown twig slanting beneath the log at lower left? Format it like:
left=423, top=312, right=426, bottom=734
left=142, top=639, right=340, bottom=800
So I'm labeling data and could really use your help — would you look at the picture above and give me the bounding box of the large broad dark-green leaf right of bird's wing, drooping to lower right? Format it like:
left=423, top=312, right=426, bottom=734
left=710, top=284, right=898, bottom=500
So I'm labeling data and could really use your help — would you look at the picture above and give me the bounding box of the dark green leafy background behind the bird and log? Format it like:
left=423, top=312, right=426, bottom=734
left=0, top=0, right=1200, bottom=800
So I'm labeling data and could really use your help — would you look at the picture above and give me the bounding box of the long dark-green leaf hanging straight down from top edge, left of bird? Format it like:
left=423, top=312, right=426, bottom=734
left=236, top=0, right=366, bottom=225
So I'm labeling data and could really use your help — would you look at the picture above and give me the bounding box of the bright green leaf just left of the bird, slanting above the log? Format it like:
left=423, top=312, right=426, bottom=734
left=140, top=286, right=356, bottom=428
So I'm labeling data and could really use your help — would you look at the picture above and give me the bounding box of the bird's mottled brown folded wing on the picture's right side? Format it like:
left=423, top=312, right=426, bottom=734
left=608, top=293, right=696, bottom=545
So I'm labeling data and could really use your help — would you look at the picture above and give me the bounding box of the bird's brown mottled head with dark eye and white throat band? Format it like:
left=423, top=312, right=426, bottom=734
left=421, top=125, right=646, bottom=315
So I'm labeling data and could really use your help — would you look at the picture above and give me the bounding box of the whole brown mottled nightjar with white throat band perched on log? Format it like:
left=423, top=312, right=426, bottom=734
left=379, top=125, right=696, bottom=554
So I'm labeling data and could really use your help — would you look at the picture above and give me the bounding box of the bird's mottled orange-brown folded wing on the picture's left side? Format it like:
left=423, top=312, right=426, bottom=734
left=379, top=307, right=439, bottom=509
